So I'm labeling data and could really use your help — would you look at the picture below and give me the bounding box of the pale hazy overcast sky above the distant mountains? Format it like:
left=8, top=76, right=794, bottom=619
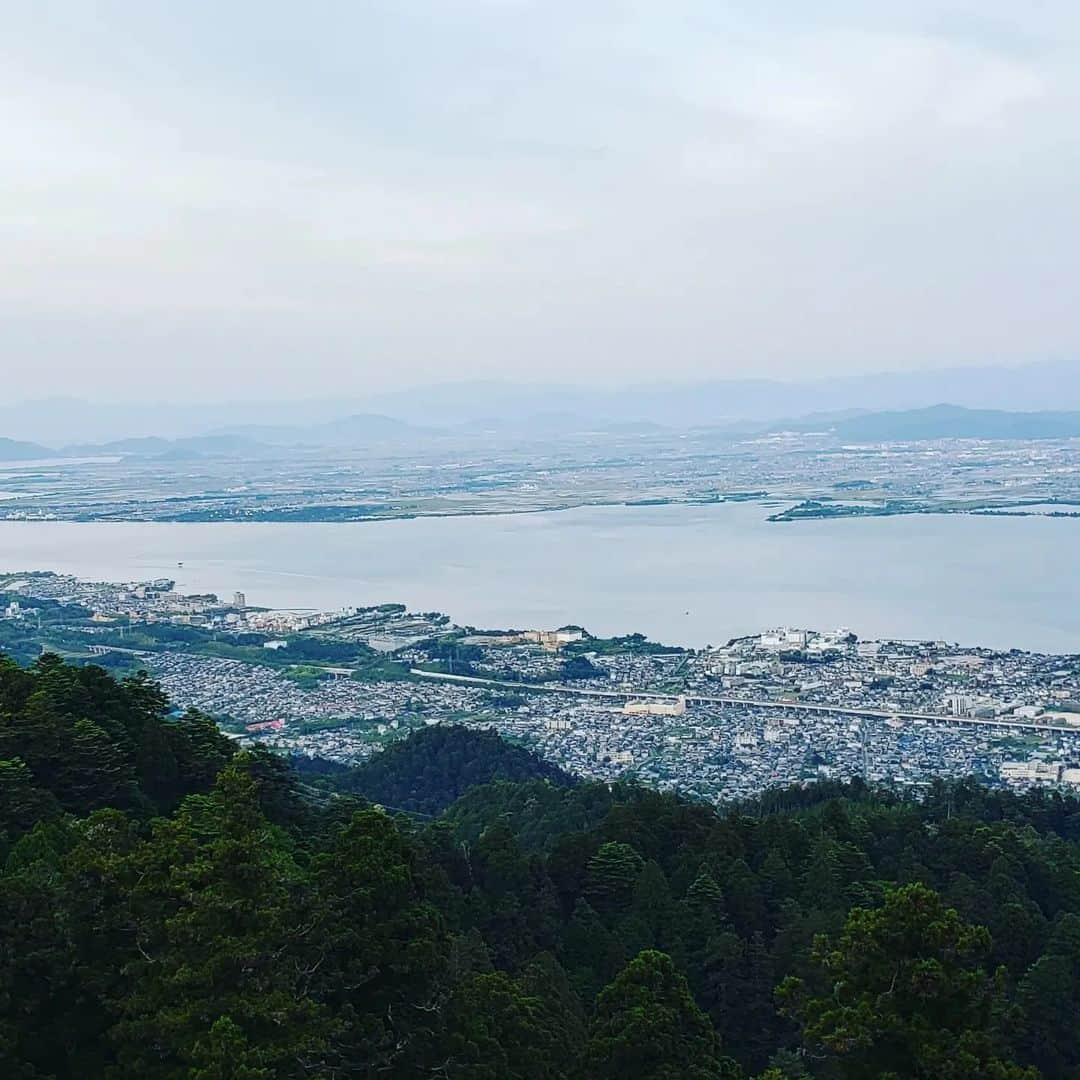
left=0, top=0, right=1080, bottom=400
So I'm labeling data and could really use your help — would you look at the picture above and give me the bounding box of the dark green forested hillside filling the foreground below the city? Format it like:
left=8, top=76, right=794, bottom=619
left=0, top=658, right=1080, bottom=1080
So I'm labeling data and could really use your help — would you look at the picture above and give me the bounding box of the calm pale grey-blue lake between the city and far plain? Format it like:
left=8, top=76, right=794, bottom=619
left=0, top=504, right=1080, bottom=652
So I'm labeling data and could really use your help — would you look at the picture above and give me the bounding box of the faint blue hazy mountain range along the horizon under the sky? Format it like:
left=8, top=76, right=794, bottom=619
left=0, top=361, right=1080, bottom=448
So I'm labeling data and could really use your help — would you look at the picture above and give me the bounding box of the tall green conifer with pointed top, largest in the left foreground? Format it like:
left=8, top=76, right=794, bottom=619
left=112, top=762, right=334, bottom=1080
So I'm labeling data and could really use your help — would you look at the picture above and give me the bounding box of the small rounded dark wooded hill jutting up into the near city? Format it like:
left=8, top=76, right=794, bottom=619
left=294, top=725, right=575, bottom=814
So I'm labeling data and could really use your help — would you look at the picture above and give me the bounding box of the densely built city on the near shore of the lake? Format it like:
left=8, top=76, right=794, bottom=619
left=0, top=572, right=1080, bottom=801
